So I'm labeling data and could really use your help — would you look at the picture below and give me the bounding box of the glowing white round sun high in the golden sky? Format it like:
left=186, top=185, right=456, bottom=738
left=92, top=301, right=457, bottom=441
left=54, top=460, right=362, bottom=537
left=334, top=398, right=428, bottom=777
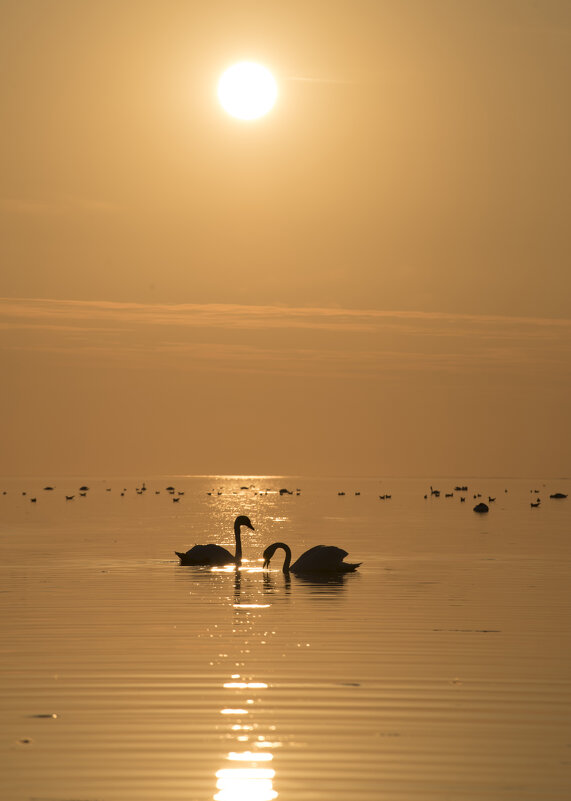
left=218, top=61, right=278, bottom=120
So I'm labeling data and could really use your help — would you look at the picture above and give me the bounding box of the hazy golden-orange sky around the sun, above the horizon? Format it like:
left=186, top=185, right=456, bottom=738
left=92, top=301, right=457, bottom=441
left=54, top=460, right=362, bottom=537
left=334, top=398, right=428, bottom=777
left=0, top=0, right=571, bottom=478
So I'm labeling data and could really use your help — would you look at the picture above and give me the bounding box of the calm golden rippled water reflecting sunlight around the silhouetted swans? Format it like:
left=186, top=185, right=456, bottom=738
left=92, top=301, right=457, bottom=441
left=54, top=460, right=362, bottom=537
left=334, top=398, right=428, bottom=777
left=0, top=477, right=571, bottom=801
